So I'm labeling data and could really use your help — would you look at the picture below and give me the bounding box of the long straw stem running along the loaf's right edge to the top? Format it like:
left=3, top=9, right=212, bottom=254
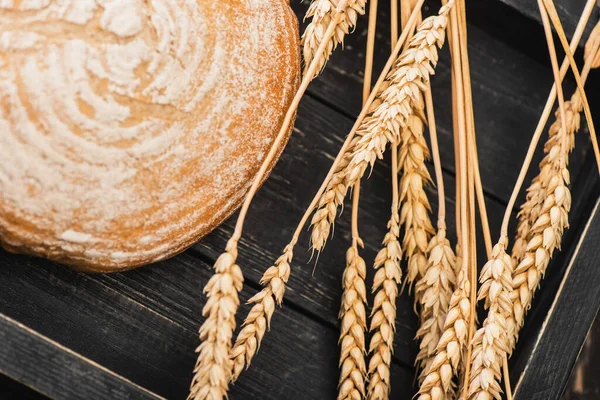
left=230, top=0, right=348, bottom=243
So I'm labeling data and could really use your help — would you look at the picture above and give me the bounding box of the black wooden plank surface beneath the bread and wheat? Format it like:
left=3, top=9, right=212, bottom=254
left=0, top=0, right=600, bottom=400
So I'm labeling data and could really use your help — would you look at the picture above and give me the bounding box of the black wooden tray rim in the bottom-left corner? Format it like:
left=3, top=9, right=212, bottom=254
left=0, top=314, right=163, bottom=399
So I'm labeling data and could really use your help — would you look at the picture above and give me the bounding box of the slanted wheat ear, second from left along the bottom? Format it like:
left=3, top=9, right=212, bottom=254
left=229, top=243, right=294, bottom=381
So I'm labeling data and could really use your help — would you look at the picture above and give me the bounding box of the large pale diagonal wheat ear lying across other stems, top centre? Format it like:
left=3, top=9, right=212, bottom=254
left=311, top=1, right=454, bottom=251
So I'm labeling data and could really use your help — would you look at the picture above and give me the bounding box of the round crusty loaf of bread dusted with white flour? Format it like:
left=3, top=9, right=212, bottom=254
left=0, top=0, right=300, bottom=271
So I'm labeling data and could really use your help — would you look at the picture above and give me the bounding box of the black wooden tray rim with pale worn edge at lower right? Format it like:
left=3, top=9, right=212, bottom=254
left=508, top=195, right=600, bottom=400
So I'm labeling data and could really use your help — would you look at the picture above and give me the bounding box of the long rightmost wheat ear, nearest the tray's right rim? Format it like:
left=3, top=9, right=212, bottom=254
left=511, top=93, right=583, bottom=349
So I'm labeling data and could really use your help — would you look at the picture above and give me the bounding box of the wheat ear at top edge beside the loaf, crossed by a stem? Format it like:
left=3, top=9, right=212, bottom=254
left=300, top=0, right=366, bottom=76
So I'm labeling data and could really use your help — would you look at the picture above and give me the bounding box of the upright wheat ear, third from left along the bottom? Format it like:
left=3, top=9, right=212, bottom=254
left=338, top=246, right=367, bottom=400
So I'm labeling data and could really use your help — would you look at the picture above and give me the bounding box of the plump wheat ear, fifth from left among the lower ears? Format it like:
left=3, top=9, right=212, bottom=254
left=415, top=228, right=456, bottom=381
